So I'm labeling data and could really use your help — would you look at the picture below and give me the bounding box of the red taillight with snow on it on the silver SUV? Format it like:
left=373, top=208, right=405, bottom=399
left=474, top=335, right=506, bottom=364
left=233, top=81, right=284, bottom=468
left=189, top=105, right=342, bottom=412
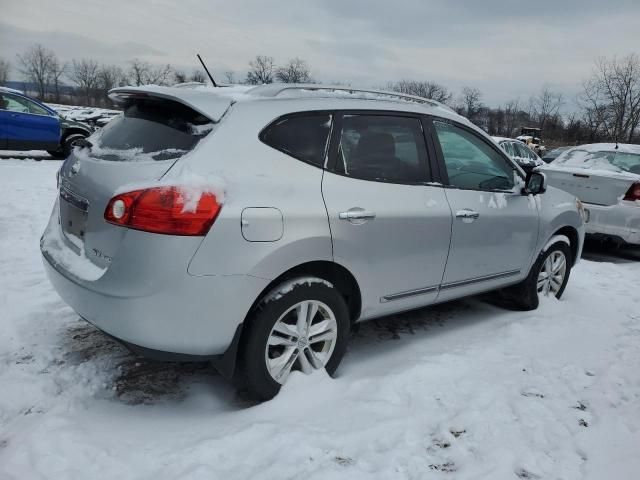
left=104, top=187, right=221, bottom=236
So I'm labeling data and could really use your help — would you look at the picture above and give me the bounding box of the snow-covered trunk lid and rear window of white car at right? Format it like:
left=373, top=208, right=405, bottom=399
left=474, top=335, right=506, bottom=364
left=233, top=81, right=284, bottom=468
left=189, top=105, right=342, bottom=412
left=543, top=148, right=640, bottom=205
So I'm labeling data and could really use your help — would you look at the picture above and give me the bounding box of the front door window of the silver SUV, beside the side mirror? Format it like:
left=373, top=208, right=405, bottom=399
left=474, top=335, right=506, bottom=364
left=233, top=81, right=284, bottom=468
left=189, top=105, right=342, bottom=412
left=433, top=120, right=515, bottom=191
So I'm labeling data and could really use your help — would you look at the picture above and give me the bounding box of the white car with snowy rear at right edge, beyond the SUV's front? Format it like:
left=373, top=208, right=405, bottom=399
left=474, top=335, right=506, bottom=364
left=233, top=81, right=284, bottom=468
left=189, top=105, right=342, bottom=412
left=542, top=143, right=640, bottom=245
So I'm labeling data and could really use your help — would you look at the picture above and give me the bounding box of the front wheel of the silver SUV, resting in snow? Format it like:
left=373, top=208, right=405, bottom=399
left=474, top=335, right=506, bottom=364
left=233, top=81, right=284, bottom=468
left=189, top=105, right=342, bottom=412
left=501, top=240, right=572, bottom=311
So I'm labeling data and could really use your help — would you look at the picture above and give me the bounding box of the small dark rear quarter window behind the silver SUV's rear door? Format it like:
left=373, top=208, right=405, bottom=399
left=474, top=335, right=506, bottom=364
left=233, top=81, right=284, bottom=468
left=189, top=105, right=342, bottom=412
left=260, top=113, right=331, bottom=167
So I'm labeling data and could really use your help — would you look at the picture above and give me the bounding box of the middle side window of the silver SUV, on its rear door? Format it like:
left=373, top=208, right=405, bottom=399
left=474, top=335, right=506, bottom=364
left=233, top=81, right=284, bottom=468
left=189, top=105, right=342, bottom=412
left=335, top=115, right=428, bottom=184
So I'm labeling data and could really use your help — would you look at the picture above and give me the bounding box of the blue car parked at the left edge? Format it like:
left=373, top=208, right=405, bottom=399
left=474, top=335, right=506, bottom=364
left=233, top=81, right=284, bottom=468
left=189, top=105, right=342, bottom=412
left=0, top=87, right=92, bottom=158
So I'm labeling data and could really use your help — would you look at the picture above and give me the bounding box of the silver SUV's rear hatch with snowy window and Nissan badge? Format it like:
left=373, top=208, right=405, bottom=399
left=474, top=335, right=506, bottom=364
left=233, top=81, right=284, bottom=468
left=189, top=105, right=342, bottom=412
left=53, top=89, right=230, bottom=269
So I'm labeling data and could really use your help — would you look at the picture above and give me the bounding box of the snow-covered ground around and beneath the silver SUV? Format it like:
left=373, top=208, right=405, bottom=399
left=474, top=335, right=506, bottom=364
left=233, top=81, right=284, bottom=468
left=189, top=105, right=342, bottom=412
left=0, top=160, right=640, bottom=480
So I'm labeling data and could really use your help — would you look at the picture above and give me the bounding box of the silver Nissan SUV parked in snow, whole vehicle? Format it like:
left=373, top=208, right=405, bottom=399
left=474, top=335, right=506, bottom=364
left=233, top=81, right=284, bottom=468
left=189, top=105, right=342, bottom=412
left=41, top=85, right=584, bottom=399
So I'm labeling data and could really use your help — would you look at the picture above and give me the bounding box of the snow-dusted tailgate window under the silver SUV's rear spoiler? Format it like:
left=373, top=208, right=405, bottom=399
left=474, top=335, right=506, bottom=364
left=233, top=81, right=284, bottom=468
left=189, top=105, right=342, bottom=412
left=91, top=99, right=213, bottom=161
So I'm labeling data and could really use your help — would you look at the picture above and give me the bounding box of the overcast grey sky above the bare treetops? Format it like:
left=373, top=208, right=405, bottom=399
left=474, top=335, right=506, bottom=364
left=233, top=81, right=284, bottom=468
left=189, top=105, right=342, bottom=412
left=0, top=0, right=640, bottom=105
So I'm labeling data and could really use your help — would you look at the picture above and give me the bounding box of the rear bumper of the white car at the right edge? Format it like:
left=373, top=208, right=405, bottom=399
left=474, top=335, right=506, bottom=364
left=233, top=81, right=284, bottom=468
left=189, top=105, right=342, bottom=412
left=584, top=201, right=640, bottom=245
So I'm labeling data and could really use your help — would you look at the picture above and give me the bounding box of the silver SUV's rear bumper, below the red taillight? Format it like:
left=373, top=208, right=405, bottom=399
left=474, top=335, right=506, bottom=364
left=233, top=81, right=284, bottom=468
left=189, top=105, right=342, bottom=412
left=43, top=252, right=268, bottom=357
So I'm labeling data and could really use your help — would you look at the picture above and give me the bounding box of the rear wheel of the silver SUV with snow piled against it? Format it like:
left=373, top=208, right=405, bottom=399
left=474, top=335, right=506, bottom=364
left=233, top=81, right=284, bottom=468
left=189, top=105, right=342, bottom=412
left=236, top=277, right=350, bottom=401
